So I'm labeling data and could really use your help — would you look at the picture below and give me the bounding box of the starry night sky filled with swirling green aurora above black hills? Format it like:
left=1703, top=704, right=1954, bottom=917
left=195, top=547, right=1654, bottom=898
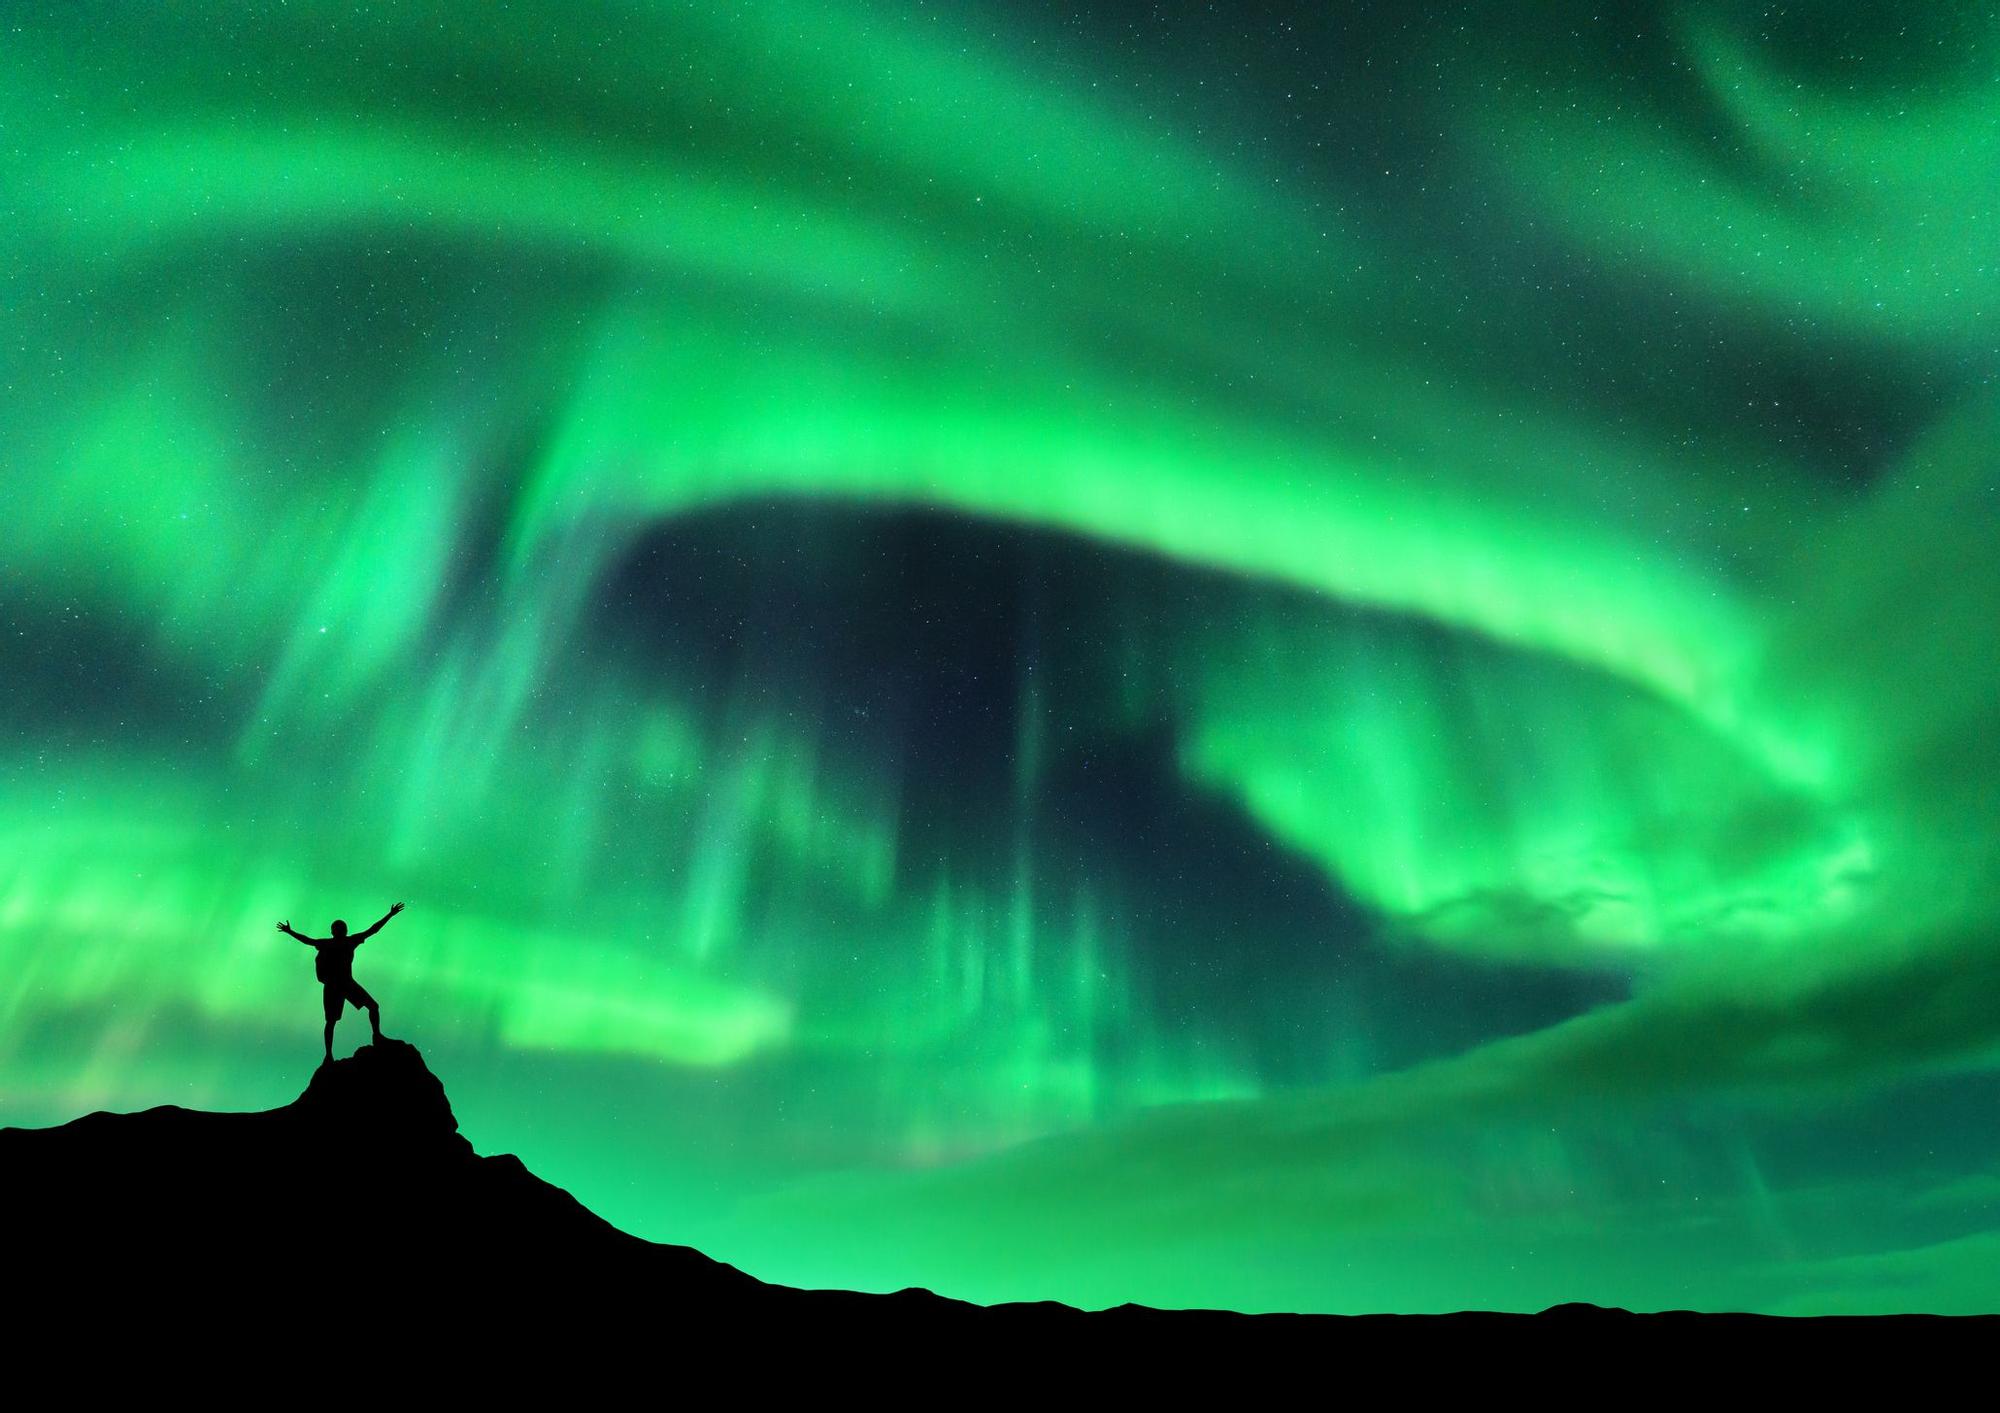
left=0, top=0, right=2000, bottom=1313
